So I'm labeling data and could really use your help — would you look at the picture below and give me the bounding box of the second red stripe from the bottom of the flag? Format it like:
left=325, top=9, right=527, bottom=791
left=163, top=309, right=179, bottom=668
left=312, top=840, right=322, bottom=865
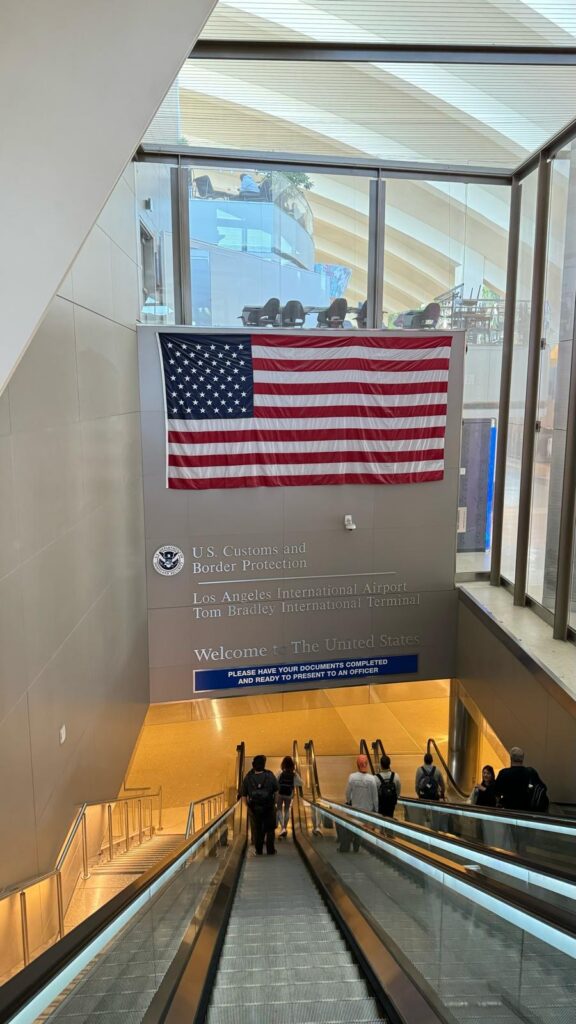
left=168, top=449, right=444, bottom=468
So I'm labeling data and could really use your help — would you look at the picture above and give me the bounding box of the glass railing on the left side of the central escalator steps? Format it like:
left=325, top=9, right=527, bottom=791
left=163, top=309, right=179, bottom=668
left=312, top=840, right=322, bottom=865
left=6, top=802, right=245, bottom=1024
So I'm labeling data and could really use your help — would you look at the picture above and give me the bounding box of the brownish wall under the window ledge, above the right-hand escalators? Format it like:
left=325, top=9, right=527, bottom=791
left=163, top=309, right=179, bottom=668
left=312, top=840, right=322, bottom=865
left=456, top=595, right=576, bottom=803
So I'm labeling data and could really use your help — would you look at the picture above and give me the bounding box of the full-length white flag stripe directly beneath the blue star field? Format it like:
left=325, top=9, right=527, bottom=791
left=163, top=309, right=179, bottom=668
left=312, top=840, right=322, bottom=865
left=168, top=416, right=446, bottom=434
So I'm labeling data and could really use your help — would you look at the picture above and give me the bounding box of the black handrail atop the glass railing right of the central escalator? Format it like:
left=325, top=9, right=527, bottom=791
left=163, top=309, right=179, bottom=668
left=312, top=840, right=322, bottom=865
left=307, top=802, right=576, bottom=941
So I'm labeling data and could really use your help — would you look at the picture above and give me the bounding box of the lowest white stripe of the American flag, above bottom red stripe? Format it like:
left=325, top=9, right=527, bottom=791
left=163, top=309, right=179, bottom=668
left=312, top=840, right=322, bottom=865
left=169, top=459, right=444, bottom=480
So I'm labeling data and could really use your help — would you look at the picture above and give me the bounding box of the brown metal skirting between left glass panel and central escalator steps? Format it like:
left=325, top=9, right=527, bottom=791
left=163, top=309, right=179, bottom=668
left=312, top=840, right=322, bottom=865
left=141, top=802, right=247, bottom=1024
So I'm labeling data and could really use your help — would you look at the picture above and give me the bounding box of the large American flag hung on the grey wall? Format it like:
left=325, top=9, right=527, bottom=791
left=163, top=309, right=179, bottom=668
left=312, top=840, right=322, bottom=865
left=158, top=332, right=452, bottom=489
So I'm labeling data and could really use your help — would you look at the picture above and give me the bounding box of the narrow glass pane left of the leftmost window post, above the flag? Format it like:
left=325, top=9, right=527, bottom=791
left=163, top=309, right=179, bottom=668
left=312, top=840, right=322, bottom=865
left=135, top=164, right=174, bottom=324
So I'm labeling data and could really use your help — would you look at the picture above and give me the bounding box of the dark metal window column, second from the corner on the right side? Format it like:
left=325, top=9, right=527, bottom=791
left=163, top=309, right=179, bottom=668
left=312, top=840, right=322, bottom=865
left=513, top=158, right=550, bottom=605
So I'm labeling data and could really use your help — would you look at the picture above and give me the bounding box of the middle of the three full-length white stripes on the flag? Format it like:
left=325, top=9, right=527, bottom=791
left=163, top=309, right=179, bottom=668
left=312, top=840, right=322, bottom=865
left=168, top=437, right=444, bottom=456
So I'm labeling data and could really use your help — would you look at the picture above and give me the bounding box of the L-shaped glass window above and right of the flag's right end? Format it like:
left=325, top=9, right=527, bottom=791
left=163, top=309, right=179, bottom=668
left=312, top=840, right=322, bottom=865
left=383, top=179, right=509, bottom=572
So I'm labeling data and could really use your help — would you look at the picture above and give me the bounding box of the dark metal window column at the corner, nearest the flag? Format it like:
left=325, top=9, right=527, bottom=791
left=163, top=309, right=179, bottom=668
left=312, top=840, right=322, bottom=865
left=490, top=179, right=522, bottom=587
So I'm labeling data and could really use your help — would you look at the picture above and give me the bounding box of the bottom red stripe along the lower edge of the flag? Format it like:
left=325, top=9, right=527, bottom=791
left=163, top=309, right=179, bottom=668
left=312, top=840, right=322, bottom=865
left=168, top=469, right=444, bottom=490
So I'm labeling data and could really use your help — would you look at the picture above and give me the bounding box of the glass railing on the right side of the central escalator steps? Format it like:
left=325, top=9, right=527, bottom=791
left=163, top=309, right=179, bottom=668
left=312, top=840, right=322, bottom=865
left=301, top=807, right=576, bottom=1024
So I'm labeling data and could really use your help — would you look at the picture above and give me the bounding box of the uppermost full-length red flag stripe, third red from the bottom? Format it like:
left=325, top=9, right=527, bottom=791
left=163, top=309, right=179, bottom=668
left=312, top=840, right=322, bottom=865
left=168, top=427, right=446, bottom=444
